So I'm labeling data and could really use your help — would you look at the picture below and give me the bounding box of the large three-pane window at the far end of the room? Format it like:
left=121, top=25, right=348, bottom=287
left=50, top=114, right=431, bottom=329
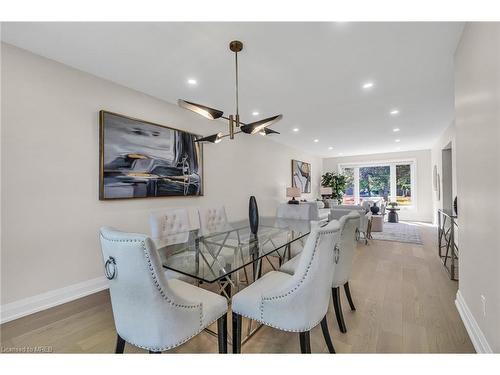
left=339, top=160, right=415, bottom=207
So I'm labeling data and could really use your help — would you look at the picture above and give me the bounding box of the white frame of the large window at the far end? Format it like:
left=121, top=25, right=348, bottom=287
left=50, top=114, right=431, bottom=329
left=337, top=158, right=417, bottom=210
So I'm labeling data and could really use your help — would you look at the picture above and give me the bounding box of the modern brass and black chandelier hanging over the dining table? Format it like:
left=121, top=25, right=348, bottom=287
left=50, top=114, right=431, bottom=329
left=178, top=40, right=283, bottom=143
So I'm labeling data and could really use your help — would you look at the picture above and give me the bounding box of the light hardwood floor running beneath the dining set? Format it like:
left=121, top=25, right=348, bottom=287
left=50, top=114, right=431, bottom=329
left=0, top=225, right=474, bottom=353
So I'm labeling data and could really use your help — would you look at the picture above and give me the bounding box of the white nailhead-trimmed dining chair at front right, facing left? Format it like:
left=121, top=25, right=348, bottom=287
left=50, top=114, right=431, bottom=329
left=232, top=221, right=339, bottom=353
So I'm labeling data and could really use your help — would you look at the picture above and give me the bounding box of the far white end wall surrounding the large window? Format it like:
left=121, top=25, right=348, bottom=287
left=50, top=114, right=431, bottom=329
left=323, top=150, right=432, bottom=222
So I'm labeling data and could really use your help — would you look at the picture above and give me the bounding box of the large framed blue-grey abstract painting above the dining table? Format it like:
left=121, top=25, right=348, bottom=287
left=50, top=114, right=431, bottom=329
left=99, top=111, right=203, bottom=200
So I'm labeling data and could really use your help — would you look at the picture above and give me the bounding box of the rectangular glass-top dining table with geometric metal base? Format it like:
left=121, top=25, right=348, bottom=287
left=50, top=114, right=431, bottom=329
left=153, top=217, right=311, bottom=344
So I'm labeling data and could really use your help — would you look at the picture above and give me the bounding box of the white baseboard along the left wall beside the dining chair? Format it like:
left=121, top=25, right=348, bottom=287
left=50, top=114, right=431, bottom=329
left=0, top=276, right=108, bottom=324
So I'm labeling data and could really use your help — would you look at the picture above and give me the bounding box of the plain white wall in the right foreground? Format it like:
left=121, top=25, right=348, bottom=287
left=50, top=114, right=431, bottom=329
left=455, top=23, right=500, bottom=353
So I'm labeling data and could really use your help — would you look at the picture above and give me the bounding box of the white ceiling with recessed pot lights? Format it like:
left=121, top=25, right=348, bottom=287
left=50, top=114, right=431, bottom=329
left=2, top=22, right=463, bottom=157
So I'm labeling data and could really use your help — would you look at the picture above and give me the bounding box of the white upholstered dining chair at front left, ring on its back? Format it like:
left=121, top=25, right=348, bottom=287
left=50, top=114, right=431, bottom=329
left=100, top=228, right=227, bottom=353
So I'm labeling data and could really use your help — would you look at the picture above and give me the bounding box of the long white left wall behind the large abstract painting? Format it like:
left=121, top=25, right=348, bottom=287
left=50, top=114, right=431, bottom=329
left=1, top=44, right=321, bottom=312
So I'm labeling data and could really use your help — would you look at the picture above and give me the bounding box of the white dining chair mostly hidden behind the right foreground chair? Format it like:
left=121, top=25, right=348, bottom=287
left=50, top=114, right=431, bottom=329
left=280, top=211, right=360, bottom=333
